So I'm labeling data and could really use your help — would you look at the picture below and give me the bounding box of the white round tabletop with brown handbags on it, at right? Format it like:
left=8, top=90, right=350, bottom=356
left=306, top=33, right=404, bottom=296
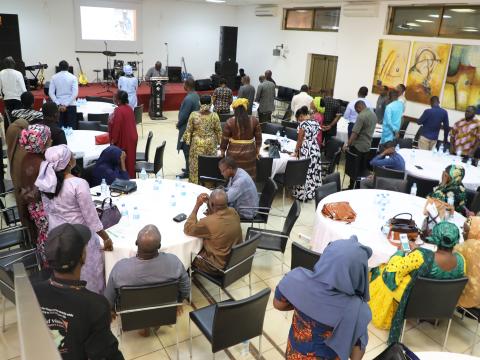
left=311, top=189, right=465, bottom=267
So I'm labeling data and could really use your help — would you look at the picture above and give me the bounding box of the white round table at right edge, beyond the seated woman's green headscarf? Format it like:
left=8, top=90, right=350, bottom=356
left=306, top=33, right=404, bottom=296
left=399, top=149, right=480, bottom=191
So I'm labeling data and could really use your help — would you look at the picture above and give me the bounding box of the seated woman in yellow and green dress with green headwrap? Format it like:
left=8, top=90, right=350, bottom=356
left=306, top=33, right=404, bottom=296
left=369, top=221, right=465, bottom=344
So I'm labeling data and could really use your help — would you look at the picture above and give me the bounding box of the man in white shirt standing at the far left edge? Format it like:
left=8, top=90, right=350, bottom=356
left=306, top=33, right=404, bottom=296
left=0, top=56, right=27, bottom=112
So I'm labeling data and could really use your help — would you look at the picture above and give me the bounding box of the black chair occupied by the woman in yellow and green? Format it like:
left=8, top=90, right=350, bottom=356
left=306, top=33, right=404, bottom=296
left=400, top=277, right=468, bottom=351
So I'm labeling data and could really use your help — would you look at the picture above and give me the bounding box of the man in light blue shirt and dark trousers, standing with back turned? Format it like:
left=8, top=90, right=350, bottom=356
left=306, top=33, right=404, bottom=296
left=48, top=60, right=78, bottom=128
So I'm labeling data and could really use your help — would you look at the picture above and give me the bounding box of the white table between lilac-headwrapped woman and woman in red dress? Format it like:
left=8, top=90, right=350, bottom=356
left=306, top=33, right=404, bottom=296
left=67, top=130, right=109, bottom=166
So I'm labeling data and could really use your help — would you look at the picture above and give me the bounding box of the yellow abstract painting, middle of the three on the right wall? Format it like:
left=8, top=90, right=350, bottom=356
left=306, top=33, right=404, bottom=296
left=405, top=41, right=451, bottom=104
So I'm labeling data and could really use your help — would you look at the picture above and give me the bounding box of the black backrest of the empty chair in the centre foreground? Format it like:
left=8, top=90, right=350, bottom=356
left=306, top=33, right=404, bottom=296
left=211, top=288, right=271, bottom=353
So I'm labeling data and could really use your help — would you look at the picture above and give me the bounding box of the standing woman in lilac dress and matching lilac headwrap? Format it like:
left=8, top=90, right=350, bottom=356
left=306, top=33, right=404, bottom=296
left=35, top=145, right=113, bottom=294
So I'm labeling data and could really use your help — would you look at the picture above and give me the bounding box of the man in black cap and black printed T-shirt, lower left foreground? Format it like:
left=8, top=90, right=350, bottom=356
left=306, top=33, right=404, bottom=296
left=33, top=223, right=123, bottom=360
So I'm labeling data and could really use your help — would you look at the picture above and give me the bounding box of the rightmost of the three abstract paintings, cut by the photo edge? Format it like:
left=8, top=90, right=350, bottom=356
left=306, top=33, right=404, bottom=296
left=442, top=45, right=480, bottom=111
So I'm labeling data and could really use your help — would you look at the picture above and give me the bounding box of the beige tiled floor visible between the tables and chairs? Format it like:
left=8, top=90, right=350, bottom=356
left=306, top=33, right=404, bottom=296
left=0, top=112, right=480, bottom=360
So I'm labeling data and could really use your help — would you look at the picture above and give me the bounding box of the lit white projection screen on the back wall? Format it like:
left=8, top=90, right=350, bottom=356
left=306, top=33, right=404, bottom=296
left=80, top=6, right=136, bottom=41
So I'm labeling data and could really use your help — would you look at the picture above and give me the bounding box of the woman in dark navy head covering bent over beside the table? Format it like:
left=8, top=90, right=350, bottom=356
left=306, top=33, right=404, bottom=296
left=91, top=145, right=130, bottom=186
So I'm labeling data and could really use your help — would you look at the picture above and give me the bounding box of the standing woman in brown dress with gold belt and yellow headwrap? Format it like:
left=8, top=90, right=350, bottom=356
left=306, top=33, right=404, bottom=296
left=220, top=98, right=262, bottom=180
